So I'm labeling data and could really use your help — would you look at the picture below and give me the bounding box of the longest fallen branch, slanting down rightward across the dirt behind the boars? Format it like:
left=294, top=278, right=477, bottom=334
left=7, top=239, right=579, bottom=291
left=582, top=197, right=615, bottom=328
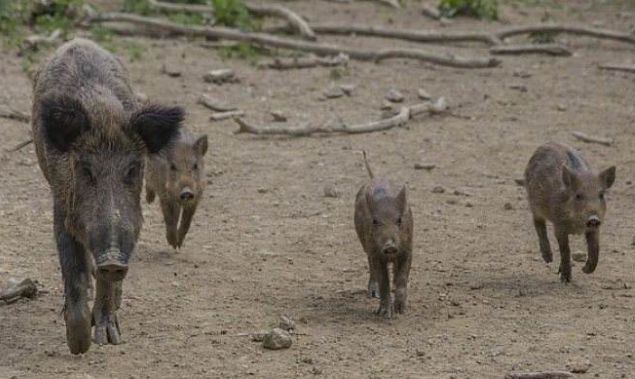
left=89, top=13, right=501, bottom=68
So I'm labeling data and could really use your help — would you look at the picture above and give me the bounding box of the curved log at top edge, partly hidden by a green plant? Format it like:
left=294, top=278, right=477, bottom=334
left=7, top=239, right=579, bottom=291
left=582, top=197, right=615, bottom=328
left=149, top=0, right=316, bottom=41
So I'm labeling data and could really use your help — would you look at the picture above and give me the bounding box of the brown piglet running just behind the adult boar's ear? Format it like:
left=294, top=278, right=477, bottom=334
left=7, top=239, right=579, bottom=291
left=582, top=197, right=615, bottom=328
left=146, top=128, right=207, bottom=248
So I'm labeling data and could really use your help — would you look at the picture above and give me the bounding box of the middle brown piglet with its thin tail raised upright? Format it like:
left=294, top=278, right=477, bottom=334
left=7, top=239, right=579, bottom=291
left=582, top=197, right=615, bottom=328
left=354, top=152, right=413, bottom=318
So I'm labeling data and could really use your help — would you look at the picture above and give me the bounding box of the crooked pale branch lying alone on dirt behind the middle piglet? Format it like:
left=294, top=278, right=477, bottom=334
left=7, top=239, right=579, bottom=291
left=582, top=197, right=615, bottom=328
left=234, top=98, right=447, bottom=137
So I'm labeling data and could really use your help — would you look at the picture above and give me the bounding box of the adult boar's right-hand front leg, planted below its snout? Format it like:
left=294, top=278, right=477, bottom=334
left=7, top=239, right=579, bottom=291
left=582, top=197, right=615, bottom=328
left=93, top=279, right=121, bottom=345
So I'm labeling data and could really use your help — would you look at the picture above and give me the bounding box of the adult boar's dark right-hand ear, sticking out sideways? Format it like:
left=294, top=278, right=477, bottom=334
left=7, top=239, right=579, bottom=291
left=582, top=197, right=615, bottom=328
left=130, top=105, right=185, bottom=154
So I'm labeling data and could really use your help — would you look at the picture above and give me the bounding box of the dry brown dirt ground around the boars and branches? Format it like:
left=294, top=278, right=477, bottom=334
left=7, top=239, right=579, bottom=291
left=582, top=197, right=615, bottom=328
left=0, top=0, right=635, bottom=379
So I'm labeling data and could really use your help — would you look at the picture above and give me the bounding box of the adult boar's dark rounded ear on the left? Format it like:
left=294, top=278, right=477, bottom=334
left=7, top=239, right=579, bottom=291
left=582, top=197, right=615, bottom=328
left=40, top=96, right=90, bottom=153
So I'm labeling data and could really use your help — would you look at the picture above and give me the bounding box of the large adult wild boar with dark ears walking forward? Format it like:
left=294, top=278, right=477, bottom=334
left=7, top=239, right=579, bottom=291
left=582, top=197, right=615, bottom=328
left=32, top=39, right=183, bottom=354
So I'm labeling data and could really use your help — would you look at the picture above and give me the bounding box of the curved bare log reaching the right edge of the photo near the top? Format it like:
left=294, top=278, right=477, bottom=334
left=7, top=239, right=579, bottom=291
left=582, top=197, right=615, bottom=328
left=495, top=24, right=635, bottom=45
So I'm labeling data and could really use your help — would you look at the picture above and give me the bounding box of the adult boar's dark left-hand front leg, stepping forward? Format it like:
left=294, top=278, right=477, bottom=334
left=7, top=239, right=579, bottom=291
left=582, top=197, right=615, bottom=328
left=53, top=201, right=91, bottom=354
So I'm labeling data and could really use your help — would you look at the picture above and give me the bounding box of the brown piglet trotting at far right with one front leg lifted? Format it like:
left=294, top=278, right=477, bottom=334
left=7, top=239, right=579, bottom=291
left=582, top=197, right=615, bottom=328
left=525, top=143, right=615, bottom=283
